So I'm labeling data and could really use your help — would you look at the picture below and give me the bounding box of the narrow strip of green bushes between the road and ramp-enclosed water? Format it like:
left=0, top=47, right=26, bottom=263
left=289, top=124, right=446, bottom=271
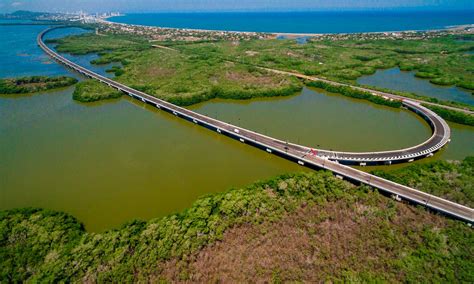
left=306, top=81, right=402, bottom=108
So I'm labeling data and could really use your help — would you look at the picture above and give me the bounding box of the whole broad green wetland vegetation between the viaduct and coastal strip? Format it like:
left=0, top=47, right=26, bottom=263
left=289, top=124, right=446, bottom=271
left=54, top=31, right=474, bottom=112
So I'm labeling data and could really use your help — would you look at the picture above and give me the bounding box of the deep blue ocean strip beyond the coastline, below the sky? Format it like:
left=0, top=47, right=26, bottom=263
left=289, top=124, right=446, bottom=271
left=109, top=11, right=474, bottom=33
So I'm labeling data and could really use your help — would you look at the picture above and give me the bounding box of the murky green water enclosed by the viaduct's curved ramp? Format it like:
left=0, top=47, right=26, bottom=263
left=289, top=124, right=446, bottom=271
left=193, top=88, right=431, bottom=151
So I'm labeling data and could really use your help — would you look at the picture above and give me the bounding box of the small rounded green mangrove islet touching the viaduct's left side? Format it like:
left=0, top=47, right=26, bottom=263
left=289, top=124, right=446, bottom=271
left=72, top=79, right=122, bottom=103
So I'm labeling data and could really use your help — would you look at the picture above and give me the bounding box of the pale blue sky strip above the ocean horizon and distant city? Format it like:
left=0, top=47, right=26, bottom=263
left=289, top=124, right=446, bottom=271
left=0, top=0, right=474, bottom=13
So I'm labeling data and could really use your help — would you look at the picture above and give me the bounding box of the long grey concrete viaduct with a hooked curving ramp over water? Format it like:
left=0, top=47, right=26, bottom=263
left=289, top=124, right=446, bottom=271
left=37, top=28, right=474, bottom=223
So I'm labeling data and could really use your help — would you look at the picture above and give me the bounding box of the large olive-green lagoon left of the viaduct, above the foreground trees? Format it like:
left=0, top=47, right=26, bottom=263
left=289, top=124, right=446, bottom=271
left=0, top=89, right=301, bottom=231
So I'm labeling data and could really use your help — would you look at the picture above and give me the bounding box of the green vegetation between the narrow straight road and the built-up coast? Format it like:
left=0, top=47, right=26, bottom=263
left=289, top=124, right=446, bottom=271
left=174, top=36, right=474, bottom=105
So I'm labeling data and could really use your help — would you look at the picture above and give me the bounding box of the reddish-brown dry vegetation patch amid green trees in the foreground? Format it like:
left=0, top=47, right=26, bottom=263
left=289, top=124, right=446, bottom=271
left=162, top=199, right=445, bottom=283
